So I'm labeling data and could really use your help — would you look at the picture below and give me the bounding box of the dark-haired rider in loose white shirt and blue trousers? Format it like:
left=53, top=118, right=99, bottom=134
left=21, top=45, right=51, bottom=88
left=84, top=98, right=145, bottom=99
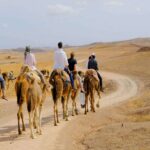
left=54, top=42, right=74, bottom=89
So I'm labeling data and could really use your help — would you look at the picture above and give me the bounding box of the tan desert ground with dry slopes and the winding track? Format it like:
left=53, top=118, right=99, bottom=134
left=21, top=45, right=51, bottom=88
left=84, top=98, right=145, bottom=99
left=0, top=40, right=150, bottom=150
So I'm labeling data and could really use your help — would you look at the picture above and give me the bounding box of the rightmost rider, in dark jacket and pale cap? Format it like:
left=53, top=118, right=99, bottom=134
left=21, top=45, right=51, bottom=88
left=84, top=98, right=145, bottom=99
left=88, top=53, right=103, bottom=92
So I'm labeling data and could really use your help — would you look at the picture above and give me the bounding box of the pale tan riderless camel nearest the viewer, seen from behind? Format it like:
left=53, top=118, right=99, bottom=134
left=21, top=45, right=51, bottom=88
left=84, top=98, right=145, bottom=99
left=27, top=79, right=46, bottom=138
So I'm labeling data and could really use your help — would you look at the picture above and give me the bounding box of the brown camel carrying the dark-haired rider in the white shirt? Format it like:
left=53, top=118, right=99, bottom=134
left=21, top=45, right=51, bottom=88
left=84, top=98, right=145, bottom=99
left=49, top=69, right=72, bottom=126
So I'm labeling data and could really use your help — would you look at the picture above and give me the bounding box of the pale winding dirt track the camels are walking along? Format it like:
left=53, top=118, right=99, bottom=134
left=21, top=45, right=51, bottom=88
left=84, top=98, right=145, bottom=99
left=0, top=72, right=138, bottom=150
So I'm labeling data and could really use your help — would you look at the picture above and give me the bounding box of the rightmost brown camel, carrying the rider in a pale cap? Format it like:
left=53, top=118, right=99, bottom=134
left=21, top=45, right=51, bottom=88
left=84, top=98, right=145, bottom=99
left=83, top=69, right=100, bottom=114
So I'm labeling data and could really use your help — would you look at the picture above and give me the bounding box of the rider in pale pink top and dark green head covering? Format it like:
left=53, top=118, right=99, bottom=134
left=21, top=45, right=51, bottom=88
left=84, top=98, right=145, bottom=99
left=24, top=46, right=46, bottom=84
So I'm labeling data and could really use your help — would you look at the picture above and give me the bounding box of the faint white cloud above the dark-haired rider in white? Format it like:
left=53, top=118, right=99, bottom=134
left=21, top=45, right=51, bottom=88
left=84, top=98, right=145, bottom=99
left=48, top=4, right=78, bottom=15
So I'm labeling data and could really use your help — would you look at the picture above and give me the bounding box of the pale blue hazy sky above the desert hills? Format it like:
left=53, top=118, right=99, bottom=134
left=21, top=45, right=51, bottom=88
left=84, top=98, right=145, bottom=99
left=0, top=0, right=150, bottom=49
